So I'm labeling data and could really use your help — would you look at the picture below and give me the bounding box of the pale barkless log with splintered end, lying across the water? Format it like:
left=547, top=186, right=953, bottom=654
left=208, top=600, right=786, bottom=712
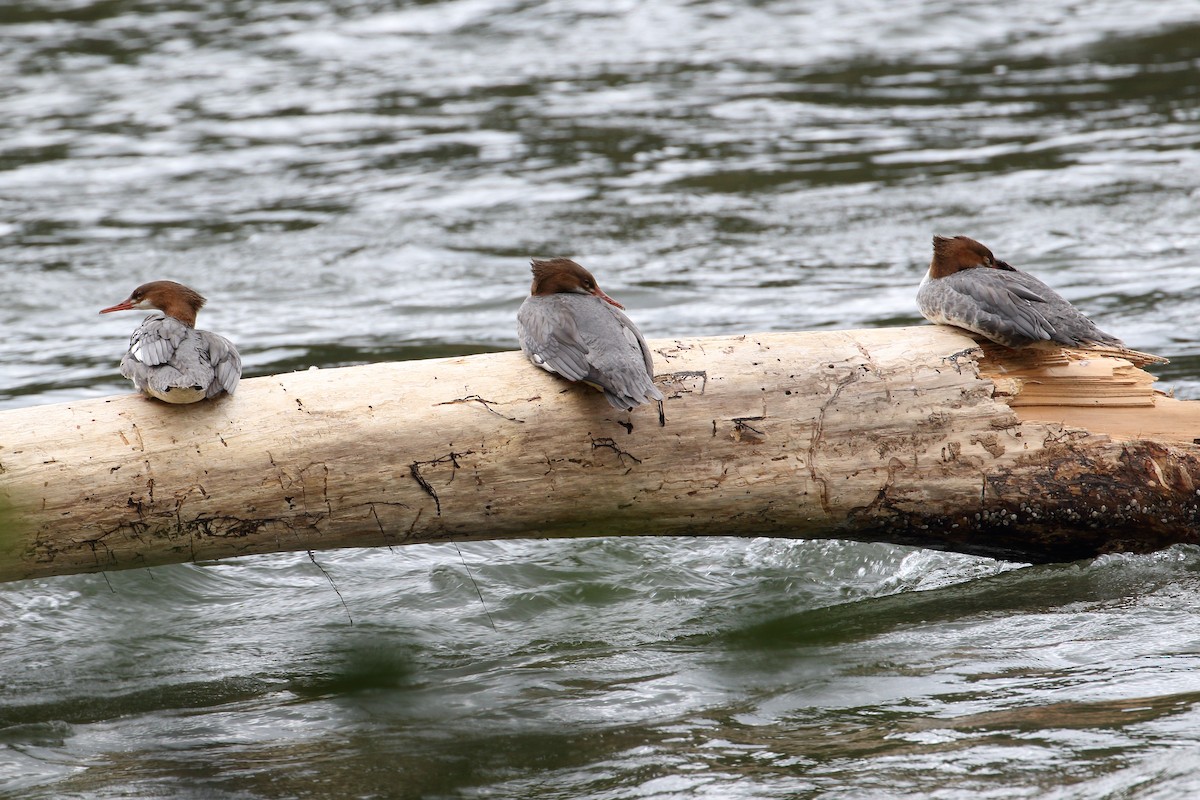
left=0, top=326, right=1200, bottom=581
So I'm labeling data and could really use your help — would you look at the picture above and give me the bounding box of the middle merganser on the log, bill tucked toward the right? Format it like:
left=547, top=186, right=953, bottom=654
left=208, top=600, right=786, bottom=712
left=517, top=258, right=662, bottom=410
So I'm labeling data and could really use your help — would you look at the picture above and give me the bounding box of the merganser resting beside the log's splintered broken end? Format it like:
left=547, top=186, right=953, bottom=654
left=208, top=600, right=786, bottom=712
left=917, top=236, right=1124, bottom=348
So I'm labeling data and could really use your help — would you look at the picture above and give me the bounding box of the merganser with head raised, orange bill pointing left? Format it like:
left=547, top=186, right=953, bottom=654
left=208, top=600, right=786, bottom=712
left=100, top=281, right=241, bottom=403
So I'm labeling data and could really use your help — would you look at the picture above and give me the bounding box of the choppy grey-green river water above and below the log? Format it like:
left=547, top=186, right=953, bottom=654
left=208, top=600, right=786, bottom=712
left=0, top=0, right=1200, bottom=799
